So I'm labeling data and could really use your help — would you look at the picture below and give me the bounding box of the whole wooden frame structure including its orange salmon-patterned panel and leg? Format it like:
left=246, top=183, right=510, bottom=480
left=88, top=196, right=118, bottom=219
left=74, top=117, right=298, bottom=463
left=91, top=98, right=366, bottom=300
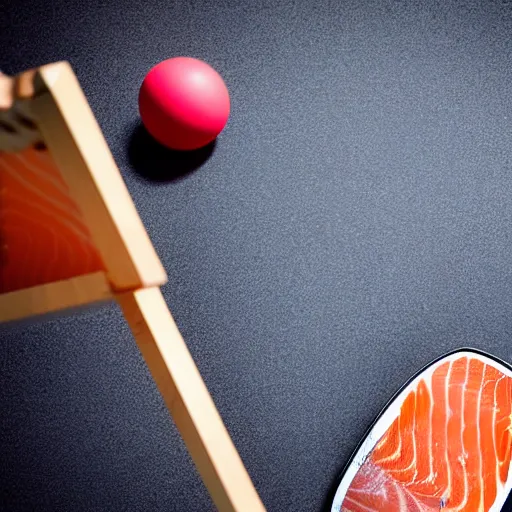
left=0, top=62, right=264, bottom=512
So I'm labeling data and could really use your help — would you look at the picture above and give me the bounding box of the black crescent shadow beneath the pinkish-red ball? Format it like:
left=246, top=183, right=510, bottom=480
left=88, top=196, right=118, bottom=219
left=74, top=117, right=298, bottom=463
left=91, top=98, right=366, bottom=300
left=128, top=124, right=216, bottom=183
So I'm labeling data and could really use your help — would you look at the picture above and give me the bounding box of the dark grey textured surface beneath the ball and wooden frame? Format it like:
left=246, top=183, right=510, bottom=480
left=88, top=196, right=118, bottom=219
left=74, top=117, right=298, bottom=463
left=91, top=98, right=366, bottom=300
left=0, top=0, right=512, bottom=512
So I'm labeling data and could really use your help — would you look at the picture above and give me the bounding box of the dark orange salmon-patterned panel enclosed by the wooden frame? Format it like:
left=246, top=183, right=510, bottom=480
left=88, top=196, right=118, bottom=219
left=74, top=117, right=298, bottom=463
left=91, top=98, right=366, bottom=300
left=0, top=147, right=105, bottom=293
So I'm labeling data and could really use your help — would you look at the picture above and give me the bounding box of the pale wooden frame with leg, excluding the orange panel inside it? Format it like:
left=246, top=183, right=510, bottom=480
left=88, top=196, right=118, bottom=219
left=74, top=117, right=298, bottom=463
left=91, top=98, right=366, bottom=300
left=0, top=62, right=265, bottom=512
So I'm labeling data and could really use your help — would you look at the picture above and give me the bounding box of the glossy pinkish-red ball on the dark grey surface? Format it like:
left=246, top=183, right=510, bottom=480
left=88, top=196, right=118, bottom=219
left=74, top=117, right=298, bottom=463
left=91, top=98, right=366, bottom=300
left=139, top=57, right=230, bottom=150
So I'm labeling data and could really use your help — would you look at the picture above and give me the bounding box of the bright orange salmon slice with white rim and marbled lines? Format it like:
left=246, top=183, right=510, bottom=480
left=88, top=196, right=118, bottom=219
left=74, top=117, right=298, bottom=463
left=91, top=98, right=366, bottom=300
left=331, top=350, right=512, bottom=512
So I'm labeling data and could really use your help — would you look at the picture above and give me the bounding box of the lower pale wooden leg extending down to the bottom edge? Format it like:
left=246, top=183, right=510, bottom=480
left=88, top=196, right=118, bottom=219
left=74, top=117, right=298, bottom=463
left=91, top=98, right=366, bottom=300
left=117, top=287, right=265, bottom=512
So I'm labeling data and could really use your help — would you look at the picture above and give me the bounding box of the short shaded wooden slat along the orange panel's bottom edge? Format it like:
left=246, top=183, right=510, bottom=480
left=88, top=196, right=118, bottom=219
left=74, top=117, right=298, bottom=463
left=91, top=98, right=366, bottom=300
left=0, top=272, right=113, bottom=322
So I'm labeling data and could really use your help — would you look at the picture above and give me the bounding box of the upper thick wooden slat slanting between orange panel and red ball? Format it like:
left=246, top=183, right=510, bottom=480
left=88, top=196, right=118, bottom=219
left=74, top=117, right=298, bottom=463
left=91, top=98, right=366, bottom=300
left=31, top=62, right=167, bottom=291
